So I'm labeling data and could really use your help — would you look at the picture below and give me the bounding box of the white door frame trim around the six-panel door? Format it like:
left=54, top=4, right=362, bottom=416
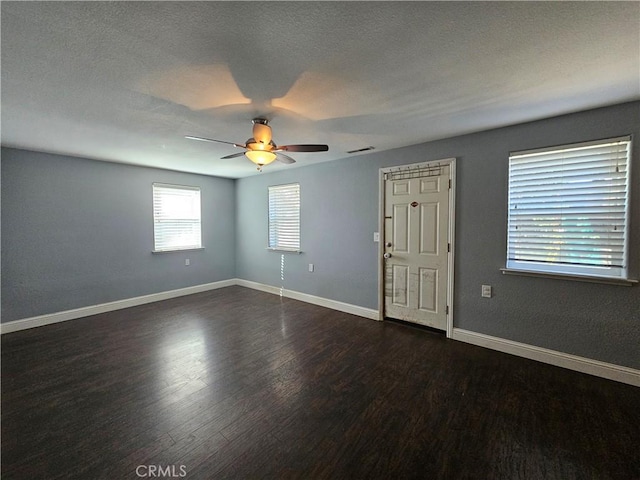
left=378, top=157, right=456, bottom=338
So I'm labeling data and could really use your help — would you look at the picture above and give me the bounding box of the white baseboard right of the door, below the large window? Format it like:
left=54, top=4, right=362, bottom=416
left=452, top=328, right=640, bottom=387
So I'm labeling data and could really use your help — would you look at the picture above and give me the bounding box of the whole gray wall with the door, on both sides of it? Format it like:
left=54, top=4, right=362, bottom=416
left=236, top=102, right=640, bottom=368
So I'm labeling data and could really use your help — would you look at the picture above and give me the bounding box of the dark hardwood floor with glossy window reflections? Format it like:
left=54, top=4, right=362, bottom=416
left=2, top=287, right=640, bottom=480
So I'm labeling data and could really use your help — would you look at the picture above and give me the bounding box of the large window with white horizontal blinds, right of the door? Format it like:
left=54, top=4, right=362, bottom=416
left=506, top=137, right=631, bottom=279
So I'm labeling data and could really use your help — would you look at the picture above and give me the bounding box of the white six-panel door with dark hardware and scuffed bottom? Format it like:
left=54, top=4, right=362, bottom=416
left=384, top=165, right=450, bottom=330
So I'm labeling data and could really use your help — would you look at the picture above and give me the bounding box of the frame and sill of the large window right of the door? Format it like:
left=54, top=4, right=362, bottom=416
left=501, top=135, right=637, bottom=285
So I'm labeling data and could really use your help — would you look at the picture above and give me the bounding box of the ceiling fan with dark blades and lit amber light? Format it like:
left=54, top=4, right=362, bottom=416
left=185, top=118, right=329, bottom=172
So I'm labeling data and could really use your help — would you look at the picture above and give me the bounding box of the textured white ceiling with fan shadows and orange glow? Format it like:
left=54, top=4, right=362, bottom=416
left=1, top=1, right=640, bottom=178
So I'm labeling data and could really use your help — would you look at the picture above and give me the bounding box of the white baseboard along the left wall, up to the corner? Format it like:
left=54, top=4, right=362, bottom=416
left=0, top=278, right=236, bottom=334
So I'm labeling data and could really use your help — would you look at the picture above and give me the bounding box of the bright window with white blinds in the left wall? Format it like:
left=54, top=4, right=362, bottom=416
left=153, top=183, right=202, bottom=252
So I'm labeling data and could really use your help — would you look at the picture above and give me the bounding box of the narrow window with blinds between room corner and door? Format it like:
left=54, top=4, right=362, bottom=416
left=269, top=183, right=300, bottom=252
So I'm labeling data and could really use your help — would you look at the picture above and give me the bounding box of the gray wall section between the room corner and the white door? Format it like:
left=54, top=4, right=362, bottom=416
left=236, top=156, right=378, bottom=309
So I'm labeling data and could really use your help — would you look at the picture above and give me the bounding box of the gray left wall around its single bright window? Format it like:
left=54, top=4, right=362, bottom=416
left=1, top=148, right=235, bottom=322
